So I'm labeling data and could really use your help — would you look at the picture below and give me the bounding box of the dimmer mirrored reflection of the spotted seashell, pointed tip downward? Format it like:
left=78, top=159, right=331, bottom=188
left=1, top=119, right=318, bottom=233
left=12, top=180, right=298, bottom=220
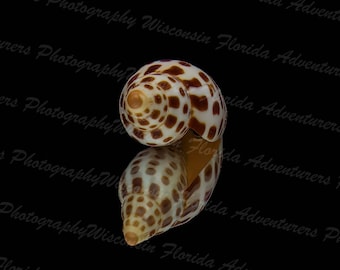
left=118, top=132, right=223, bottom=246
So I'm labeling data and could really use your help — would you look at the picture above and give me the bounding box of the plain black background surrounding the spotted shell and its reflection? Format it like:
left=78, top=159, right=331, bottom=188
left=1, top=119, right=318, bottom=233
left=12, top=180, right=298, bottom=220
left=0, top=0, right=340, bottom=270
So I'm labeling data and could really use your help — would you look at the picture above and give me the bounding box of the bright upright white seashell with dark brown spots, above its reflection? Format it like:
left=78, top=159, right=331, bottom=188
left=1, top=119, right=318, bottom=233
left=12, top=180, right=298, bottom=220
left=119, top=60, right=227, bottom=146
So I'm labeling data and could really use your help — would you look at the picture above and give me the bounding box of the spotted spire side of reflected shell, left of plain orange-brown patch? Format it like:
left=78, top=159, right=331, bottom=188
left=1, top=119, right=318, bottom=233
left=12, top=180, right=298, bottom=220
left=118, top=146, right=186, bottom=247
